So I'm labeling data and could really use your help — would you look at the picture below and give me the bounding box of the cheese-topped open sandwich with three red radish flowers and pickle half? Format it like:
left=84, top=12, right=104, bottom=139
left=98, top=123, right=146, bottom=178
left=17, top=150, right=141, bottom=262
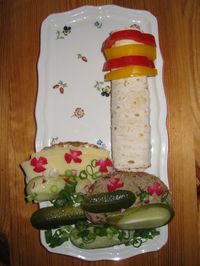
left=21, top=142, right=112, bottom=202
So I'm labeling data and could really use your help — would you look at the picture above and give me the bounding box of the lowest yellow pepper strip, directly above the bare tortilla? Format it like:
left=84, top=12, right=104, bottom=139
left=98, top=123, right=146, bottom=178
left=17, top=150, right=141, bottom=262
left=104, top=66, right=157, bottom=81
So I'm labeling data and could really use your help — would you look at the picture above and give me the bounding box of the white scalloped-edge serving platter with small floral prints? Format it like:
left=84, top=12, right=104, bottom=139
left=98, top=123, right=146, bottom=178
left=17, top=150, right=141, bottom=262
left=35, top=5, right=168, bottom=261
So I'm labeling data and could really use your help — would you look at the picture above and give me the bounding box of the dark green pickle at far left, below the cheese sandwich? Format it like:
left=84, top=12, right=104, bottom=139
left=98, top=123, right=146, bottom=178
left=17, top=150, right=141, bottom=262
left=31, top=206, right=85, bottom=230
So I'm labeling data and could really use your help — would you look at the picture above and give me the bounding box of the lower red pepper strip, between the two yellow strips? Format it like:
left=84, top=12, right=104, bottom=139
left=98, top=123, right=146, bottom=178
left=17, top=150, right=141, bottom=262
left=103, top=55, right=155, bottom=71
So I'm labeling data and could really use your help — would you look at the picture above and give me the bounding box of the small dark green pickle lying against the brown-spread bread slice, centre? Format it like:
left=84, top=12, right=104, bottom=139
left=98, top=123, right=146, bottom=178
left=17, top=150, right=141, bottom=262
left=81, top=190, right=136, bottom=213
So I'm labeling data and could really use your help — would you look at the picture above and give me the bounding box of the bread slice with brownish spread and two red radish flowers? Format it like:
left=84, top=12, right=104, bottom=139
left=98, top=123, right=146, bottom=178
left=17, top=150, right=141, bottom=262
left=86, top=171, right=172, bottom=224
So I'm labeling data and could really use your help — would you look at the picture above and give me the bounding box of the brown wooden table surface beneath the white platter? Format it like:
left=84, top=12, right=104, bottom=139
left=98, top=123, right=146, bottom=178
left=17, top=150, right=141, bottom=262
left=0, top=0, right=200, bottom=266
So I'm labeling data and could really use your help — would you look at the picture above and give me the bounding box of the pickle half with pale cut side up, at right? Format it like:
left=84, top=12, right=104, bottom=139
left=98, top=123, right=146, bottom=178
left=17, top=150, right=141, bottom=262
left=107, top=203, right=174, bottom=229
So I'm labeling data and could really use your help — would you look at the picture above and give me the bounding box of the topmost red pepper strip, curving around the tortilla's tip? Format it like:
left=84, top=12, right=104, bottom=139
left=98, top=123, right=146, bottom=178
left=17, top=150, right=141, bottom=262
left=102, top=29, right=156, bottom=51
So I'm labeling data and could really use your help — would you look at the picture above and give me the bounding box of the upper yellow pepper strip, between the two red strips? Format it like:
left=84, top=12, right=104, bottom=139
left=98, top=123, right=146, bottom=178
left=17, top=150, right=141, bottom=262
left=104, top=44, right=156, bottom=60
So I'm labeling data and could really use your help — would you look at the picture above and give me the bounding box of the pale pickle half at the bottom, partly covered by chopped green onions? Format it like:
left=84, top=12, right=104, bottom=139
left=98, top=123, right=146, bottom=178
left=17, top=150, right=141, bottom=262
left=70, top=226, right=123, bottom=249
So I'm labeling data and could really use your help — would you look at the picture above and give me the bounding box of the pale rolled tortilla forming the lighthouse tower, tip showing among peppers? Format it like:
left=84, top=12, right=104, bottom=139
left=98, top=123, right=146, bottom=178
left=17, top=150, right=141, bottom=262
left=111, top=28, right=151, bottom=171
